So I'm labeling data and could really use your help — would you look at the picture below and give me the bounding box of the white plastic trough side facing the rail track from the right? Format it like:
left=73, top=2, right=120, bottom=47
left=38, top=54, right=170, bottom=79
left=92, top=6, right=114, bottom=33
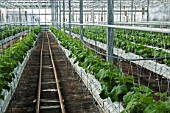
left=55, top=38, right=124, bottom=113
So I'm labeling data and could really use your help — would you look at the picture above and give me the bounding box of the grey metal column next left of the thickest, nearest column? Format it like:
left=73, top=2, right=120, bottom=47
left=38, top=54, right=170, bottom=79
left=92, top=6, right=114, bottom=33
left=80, top=0, right=83, bottom=40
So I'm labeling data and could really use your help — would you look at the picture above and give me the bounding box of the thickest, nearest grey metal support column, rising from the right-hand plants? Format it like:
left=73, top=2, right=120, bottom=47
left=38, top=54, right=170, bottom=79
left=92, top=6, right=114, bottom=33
left=107, top=0, right=114, bottom=62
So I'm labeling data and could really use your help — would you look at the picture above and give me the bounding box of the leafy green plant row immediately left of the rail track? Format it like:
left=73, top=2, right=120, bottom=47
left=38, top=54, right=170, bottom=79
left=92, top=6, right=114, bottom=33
left=0, top=27, right=40, bottom=99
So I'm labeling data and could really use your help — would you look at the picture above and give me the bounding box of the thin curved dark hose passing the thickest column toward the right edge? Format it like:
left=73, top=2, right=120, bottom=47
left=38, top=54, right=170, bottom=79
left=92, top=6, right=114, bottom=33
left=80, top=40, right=170, bottom=61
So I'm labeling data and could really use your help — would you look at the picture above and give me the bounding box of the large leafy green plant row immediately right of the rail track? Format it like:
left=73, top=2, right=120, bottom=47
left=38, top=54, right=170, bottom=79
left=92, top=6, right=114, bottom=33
left=50, top=27, right=170, bottom=113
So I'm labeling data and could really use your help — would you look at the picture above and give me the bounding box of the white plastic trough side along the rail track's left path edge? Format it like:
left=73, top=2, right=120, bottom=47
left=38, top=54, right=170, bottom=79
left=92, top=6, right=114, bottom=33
left=0, top=33, right=38, bottom=113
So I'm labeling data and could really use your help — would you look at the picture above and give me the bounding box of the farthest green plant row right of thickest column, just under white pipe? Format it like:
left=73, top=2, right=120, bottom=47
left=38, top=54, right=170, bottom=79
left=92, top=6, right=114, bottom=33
left=115, top=29, right=170, bottom=49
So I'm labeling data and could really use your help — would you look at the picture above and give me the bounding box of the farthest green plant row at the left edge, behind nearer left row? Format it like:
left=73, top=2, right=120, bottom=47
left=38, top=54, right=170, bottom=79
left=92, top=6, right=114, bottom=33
left=0, top=26, right=29, bottom=40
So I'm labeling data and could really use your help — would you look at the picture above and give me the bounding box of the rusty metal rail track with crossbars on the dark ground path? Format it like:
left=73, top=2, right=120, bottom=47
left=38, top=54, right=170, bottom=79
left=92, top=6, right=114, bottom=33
left=36, top=32, right=65, bottom=113
